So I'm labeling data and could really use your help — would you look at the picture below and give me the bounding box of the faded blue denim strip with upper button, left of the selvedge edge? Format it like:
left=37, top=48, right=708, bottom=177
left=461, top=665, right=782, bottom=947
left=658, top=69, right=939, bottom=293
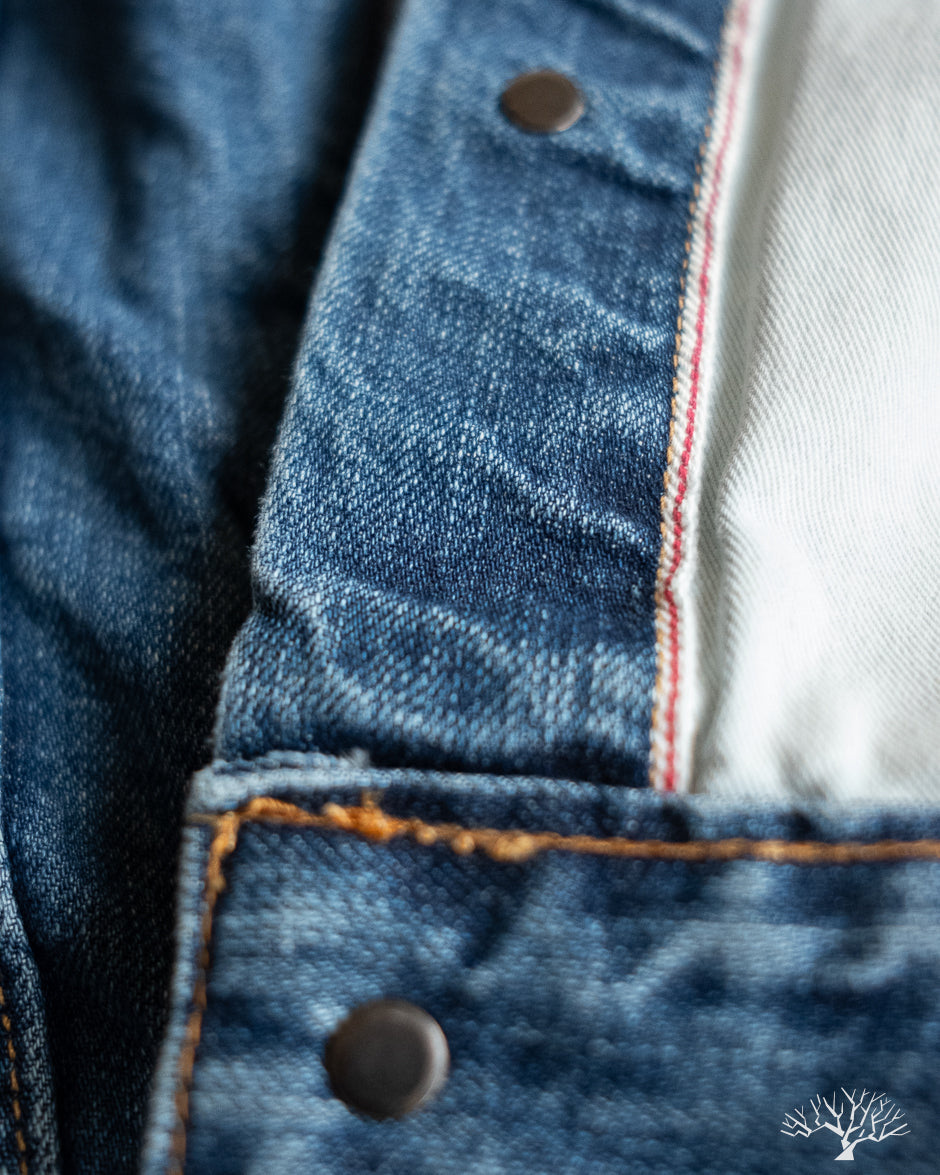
left=216, top=0, right=723, bottom=785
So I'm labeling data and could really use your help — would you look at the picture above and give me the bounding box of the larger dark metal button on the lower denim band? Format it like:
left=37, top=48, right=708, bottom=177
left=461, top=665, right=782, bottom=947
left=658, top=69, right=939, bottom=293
left=323, top=1000, right=450, bottom=1117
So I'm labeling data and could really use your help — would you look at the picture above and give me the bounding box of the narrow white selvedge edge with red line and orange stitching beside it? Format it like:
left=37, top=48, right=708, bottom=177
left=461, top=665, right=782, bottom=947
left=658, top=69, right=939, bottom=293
left=650, top=0, right=750, bottom=792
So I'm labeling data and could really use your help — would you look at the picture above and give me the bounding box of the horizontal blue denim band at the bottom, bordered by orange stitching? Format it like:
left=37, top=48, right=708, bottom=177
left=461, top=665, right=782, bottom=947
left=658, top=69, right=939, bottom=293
left=143, top=756, right=940, bottom=1175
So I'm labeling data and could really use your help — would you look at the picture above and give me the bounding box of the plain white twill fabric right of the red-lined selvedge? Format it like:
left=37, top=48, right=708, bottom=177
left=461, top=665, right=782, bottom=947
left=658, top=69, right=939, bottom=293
left=674, top=0, right=940, bottom=803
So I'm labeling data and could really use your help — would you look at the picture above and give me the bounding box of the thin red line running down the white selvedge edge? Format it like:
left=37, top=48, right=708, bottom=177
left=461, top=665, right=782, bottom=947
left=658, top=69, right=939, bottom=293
left=663, top=0, right=751, bottom=792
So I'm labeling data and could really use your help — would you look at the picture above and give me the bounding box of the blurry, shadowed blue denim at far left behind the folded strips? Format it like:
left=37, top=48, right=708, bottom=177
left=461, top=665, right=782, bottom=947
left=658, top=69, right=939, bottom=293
left=0, top=0, right=392, bottom=1175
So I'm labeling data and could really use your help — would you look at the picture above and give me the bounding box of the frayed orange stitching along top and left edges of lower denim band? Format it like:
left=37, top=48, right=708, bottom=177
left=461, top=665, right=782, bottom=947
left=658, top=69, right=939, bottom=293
left=166, top=791, right=940, bottom=1175
